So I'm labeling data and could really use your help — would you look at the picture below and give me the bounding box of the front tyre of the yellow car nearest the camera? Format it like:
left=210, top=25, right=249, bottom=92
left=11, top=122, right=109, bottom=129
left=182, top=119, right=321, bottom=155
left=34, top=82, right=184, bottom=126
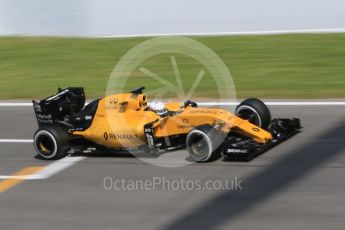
left=186, top=125, right=224, bottom=162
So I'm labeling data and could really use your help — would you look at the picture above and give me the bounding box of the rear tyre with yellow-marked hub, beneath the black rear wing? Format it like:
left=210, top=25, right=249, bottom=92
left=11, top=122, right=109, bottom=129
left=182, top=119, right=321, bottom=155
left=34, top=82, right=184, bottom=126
left=34, top=126, right=70, bottom=160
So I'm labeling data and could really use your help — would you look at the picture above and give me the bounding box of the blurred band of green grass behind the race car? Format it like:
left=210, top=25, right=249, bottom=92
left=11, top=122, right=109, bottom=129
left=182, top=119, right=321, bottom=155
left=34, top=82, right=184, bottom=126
left=0, top=34, right=345, bottom=99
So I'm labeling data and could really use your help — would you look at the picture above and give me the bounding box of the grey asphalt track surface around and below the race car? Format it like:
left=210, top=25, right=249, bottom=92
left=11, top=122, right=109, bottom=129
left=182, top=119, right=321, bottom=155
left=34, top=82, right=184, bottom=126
left=0, top=106, right=345, bottom=230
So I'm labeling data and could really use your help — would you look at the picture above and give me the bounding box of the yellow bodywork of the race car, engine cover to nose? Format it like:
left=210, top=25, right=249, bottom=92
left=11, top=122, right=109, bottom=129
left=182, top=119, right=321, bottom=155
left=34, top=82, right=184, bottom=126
left=72, top=93, right=272, bottom=148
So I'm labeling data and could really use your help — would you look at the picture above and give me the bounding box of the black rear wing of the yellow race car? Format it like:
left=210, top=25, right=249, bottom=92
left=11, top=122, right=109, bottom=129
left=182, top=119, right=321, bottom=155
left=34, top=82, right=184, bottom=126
left=32, top=87, right=85, bottom=127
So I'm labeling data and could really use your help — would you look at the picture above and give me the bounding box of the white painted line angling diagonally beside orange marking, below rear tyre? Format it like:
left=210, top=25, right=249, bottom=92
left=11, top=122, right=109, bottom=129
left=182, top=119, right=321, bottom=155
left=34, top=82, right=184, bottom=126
left=0, top=157, right=85, bottom=180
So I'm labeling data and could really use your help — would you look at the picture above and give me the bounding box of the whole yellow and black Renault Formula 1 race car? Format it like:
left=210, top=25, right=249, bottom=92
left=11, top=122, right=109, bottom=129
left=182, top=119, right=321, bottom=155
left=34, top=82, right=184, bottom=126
left=33, top=87, right=301, bottom=162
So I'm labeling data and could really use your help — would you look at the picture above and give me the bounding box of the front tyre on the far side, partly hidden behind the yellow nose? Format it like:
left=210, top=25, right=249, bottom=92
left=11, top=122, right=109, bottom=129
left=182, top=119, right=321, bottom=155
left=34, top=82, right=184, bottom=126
left=235, top=98, right=271, bottom=129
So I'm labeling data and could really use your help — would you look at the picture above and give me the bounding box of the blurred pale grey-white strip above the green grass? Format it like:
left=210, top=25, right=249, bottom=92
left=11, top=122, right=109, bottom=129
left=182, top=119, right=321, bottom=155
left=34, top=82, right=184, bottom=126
left=0, top=0, right=345, bottom=36
